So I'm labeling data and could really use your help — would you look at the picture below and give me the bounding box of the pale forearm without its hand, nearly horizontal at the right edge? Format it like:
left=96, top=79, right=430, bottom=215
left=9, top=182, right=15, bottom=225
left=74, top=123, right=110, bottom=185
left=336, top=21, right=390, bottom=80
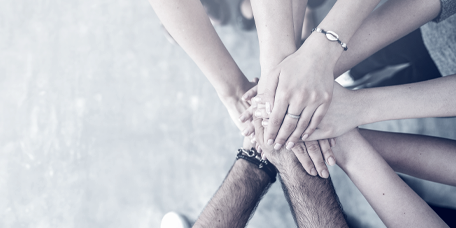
left=356, top=75, right=456, bottom=124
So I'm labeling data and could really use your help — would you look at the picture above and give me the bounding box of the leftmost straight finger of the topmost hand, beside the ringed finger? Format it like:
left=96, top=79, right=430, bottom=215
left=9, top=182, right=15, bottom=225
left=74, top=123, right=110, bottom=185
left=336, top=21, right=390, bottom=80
left=264, top=96, right=288, bottom=145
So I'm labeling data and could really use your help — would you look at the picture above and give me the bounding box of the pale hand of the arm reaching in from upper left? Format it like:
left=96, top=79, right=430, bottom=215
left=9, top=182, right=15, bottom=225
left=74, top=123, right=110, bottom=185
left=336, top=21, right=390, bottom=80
left=221, top=78, right=258, bottom=136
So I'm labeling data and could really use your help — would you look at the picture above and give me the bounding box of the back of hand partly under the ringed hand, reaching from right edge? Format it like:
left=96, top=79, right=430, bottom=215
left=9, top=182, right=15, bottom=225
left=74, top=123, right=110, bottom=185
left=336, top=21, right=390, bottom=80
left=307, top=83, right=368, bottom=140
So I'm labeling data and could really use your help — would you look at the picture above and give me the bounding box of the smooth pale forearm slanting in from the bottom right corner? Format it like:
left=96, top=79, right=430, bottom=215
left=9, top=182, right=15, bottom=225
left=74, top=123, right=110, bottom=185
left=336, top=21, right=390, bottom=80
left=333, top=130, right=447, bottom=227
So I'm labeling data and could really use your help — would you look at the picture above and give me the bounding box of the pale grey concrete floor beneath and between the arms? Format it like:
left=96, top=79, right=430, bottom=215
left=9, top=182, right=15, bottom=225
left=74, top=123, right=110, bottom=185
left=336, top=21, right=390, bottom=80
left=0, top=0, right=456, bottom=228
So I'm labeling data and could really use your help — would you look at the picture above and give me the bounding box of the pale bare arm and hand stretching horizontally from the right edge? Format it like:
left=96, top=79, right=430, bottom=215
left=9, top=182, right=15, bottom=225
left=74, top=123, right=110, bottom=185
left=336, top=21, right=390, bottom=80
left=309, top=75, right=456, bottom=140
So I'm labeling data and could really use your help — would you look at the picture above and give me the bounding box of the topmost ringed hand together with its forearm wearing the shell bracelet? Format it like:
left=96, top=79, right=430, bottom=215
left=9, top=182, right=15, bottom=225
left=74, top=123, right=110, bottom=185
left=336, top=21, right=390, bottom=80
left=252, top=0, right=379, bottom=149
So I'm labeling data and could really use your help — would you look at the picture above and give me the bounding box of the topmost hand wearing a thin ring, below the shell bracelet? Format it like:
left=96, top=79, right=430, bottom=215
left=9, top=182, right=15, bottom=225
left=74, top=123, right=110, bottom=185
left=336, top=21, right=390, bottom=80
left=258, top=36, right=337, bottom=149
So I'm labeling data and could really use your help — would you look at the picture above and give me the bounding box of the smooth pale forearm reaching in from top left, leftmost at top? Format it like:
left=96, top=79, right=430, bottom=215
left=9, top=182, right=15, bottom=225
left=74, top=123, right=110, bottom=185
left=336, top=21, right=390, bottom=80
left=149, top=0, right=249, bottom=98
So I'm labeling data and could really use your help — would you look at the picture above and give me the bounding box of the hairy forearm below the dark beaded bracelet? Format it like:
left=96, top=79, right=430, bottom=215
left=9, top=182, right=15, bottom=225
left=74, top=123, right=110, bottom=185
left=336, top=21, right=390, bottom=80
left=193, top=159, right=270, bottom=228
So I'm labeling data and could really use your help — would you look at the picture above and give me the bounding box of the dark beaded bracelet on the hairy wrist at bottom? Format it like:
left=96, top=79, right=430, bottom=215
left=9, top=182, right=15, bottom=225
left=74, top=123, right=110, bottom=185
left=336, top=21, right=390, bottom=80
left=236, top=148, right=277, bottom=184
